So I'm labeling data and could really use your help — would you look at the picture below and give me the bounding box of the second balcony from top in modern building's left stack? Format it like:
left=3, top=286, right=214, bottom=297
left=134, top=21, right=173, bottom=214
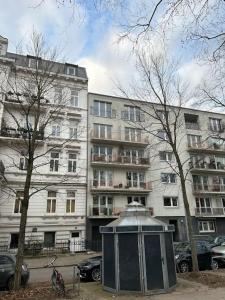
left=91, top=154, right=150, bottom=169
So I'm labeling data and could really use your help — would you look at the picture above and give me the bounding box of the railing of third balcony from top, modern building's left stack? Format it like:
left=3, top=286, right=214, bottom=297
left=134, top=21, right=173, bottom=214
left=90, top=180, right=152, bottom=191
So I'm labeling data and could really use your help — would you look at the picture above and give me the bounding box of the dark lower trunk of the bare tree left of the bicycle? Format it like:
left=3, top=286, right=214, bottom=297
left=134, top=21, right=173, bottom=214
left=14, top=161, right=33, bottom=290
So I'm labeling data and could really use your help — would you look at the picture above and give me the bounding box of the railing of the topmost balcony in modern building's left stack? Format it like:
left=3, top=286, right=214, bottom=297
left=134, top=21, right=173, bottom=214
left=91, top=131, right=149, bottom=144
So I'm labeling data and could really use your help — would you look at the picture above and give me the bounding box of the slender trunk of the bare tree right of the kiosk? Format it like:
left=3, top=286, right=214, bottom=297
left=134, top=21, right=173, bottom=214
left=175, top=154, right=199, bottom=272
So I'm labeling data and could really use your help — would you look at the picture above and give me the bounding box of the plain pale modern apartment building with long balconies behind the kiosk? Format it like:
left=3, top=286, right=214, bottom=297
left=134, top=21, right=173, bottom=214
left=87, top=93, right=225, bottom=244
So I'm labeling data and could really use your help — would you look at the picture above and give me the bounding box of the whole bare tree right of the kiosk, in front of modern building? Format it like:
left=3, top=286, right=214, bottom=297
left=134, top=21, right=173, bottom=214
left=120, top=50, right=198, bottom=271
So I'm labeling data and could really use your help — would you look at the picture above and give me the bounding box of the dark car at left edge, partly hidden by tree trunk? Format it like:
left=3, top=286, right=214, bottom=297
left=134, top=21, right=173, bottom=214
left=0, top=253, right=30, bottom=290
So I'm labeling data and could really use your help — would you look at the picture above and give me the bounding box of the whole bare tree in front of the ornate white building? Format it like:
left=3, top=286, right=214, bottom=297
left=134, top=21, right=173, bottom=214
left=0, top=32, right=85, bottom=289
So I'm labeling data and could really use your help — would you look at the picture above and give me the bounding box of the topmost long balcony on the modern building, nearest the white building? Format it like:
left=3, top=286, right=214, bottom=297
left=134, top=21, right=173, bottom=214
left=90, top=131, right=149, bottom=147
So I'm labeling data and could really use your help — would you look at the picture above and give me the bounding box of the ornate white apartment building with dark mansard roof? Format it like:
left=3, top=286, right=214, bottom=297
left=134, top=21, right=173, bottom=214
left=0, top=37, right=88, bottom=247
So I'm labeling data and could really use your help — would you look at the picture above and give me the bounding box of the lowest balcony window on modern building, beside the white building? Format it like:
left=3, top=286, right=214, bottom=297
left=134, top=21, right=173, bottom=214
left=93, top=195, right=113, bottom=216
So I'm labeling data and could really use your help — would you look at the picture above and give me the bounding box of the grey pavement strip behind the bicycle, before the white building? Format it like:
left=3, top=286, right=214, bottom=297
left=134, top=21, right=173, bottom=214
left=24, top=252, right=101, bottom=269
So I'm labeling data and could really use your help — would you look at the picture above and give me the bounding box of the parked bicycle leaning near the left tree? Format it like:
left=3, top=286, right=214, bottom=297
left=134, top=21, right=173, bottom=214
left=44, top=255, right=66, bottom=297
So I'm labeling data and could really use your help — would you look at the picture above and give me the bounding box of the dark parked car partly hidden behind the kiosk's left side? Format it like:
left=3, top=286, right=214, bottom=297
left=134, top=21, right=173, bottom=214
left=78, top=256, right=102, bottom=281
